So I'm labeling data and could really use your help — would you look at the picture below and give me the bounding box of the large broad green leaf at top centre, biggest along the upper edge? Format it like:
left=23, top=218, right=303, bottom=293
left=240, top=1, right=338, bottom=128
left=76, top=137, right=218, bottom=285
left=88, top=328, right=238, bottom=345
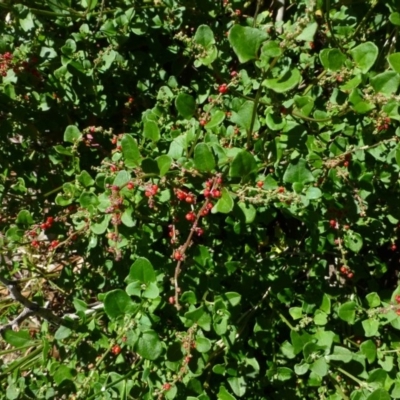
left=228, top=24, right=268, bottom=64
